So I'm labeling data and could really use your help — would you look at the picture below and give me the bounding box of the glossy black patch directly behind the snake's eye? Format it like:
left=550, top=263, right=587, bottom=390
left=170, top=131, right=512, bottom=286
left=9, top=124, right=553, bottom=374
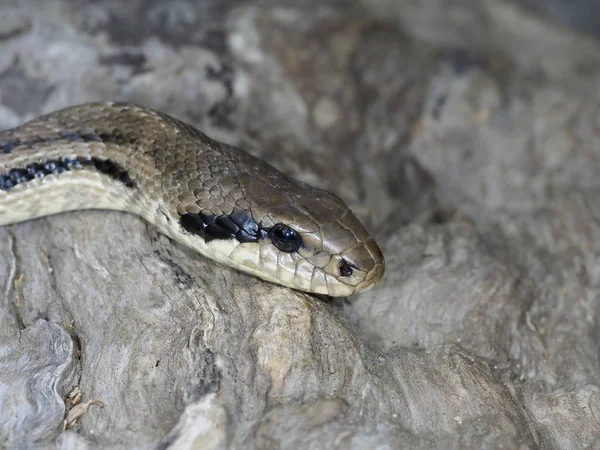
left=179, top=209, right=268, bottom=242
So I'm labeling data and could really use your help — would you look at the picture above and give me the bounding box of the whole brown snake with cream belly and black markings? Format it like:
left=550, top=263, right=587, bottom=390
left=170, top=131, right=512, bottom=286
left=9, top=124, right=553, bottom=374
left=0, top=102, right=385, bottom=297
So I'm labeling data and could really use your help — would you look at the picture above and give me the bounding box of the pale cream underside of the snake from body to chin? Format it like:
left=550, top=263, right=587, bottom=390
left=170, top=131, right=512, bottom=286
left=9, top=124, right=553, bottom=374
left=0, top=174, right=354, bottom=296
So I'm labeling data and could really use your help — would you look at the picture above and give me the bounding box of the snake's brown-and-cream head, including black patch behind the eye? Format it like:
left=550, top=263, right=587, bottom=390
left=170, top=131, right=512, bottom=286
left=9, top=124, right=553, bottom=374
left=177, top=154, right=384, bottom=297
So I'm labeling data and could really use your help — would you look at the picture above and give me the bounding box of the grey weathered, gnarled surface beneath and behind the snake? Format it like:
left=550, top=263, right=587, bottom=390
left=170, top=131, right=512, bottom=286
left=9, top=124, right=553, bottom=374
left=0, top=0, right=600, bottom=449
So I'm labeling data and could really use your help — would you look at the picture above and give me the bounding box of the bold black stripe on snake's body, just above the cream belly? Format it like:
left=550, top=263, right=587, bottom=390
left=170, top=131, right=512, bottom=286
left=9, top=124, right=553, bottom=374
left=0, top=158, right=135, bottom=191
